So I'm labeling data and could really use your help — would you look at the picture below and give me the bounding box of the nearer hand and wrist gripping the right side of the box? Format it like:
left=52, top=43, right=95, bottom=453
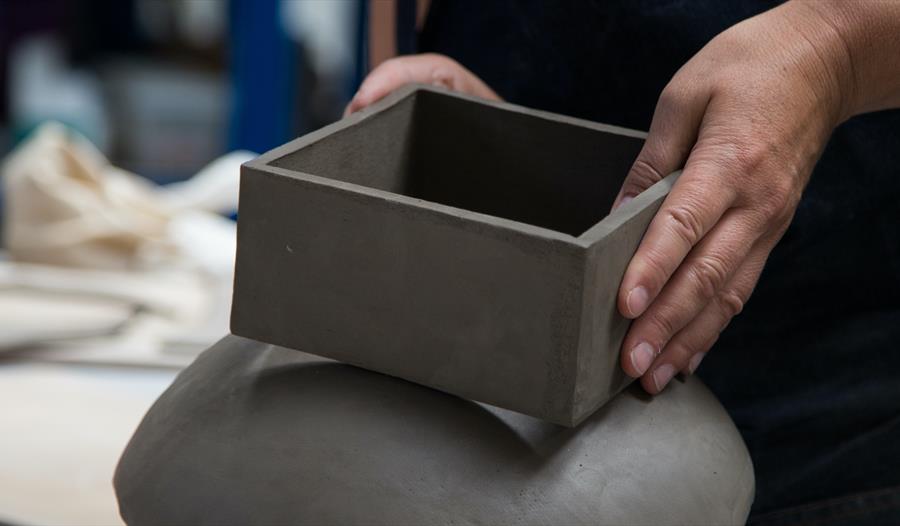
left=616, top=1, right=900, bottom=393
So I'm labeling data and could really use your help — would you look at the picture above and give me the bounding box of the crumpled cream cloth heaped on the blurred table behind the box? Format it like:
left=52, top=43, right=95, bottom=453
left=2, top=123, right=254, bottom=275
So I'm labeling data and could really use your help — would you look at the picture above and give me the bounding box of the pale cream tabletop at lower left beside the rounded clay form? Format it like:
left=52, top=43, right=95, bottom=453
left=0, top=360, right=177, bottom=526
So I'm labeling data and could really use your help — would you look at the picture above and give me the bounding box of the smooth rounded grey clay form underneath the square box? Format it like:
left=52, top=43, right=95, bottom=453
left=115, top=336, right=754, bottom=525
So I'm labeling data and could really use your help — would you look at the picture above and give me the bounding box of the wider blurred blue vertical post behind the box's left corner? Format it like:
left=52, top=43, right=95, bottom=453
left=228, top=0, right=300, bottom=156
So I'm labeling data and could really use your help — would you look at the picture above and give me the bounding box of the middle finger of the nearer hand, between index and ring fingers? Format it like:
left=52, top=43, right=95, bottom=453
left=622, top=209, right=760, bottom=378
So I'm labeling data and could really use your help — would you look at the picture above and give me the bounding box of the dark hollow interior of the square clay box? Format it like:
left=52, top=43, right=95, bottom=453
left=270, top=90, right=643, bottom=237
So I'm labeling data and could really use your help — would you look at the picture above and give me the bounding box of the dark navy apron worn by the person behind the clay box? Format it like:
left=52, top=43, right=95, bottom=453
left=418, top=0, right=900, bottom=524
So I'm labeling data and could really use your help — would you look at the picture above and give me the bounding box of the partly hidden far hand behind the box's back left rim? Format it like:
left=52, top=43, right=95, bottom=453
left=344, top=53, right=500, bottom=116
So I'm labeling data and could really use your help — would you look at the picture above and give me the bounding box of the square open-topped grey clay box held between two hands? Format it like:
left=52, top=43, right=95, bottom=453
left=231, top=86, right=676, bottom=426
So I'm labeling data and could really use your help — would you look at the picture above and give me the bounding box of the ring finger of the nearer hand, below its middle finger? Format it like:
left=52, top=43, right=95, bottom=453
left=641, top=241, right=774, bottom=394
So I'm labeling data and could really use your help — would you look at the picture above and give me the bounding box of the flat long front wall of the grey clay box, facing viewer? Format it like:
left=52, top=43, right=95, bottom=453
left=232, top=167, right=585, bottom=422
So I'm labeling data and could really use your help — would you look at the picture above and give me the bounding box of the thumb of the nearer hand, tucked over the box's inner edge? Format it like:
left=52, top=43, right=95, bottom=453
left=612, top=82, right=709, bottom=210
